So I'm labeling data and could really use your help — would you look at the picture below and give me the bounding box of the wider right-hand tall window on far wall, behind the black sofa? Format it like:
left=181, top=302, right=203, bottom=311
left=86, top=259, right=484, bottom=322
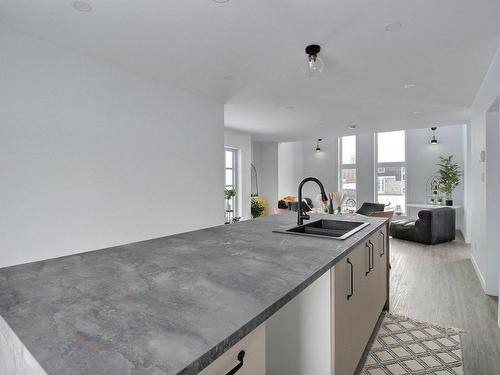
left=376, top=130, right=406, bottom=214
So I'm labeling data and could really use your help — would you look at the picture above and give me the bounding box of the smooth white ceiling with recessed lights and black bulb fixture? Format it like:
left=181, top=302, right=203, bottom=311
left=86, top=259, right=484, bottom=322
left=0, top=0, right=500, bottom=141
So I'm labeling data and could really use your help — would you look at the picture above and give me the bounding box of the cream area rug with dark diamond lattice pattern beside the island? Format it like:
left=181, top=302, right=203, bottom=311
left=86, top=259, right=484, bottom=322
left=361, top=313, right=463, bottom=375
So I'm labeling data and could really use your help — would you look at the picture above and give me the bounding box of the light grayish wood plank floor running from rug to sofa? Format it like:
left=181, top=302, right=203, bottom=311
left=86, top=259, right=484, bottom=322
left=390, top=239, right=500, bottom=375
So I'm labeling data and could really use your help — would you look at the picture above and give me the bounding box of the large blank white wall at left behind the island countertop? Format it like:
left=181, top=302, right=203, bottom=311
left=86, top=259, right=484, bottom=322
left=0, top=28, right=224, bottom=266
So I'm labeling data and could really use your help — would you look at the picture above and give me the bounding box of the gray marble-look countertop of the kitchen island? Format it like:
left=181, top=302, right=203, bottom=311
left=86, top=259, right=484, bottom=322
left=0, top=214, right=386, bottom=375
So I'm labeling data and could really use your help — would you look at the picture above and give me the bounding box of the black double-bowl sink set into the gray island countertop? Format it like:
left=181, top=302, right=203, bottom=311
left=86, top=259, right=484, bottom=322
left=273, top=219, right=370, bottom=240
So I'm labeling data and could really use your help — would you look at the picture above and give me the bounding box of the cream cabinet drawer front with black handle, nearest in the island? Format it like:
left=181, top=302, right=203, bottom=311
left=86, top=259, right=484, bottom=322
left=199, top=323, right=266, bottom=375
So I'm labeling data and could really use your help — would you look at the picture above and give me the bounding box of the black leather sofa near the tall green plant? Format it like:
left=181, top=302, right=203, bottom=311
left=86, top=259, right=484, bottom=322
left=390, top=207, right=455, bottom=245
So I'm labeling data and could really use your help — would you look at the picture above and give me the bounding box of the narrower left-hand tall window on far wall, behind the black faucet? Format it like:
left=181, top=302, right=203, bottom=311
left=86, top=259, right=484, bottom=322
left=339, top=135, right=357, bottom=208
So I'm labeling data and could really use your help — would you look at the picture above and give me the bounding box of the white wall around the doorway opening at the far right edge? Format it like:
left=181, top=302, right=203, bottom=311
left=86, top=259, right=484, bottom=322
left=467, top=44, right=500, bottom=295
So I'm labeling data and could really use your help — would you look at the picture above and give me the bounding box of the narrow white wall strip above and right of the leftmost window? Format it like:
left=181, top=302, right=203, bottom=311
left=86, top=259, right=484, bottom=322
left=224, top=129, right=252, bottom=220
